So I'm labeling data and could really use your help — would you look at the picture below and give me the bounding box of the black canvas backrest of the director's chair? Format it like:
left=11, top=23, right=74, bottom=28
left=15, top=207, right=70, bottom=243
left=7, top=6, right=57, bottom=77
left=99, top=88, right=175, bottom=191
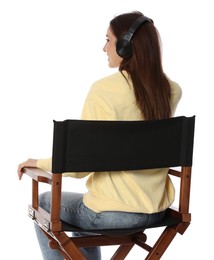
left=52, top=116, right=195, bottom=173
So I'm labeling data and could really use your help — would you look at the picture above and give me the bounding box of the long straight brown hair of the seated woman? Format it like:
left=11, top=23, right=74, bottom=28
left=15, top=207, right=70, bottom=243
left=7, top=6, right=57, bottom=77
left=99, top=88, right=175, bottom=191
left=110, top=11, right=171, bottom=120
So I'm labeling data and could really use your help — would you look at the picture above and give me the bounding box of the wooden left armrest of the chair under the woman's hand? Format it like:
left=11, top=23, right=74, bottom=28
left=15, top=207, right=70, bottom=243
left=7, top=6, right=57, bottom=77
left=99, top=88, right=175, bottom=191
left=23, top=168, right=52, bottom=184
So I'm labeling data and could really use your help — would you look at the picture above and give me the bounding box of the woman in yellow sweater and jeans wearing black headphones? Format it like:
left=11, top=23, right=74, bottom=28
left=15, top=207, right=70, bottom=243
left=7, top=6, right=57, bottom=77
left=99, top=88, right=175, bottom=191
left=18, top=12, right=181, bottom=260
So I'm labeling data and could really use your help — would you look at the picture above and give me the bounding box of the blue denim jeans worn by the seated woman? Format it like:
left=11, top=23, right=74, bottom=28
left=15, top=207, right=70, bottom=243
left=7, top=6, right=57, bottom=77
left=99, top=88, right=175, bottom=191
left=35, top=192, right=165, bottom=260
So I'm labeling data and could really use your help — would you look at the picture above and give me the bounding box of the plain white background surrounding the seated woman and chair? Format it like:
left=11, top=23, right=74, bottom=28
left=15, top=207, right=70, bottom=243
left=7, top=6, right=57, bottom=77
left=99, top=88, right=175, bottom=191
left=0, top=0, right=214, bottom=260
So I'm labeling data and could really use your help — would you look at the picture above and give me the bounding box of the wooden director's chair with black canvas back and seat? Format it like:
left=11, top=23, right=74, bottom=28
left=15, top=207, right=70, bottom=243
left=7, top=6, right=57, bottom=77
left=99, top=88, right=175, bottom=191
left=25, top=116, right=195, bottom=260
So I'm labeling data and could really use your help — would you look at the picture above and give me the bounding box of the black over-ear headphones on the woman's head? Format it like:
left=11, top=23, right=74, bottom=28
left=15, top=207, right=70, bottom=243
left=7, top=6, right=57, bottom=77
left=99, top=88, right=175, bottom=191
left=116, top=16, right=153, bottom=59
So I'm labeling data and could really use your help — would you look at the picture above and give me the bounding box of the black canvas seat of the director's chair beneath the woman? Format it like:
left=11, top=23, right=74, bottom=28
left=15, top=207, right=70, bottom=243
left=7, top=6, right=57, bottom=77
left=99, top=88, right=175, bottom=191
left=62, top=209, right=181, bottom=236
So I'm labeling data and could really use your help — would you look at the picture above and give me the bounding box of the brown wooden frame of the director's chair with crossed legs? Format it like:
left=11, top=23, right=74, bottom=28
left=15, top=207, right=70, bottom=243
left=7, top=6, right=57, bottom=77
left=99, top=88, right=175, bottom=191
left=24, top=117, right=194, bottom=260
